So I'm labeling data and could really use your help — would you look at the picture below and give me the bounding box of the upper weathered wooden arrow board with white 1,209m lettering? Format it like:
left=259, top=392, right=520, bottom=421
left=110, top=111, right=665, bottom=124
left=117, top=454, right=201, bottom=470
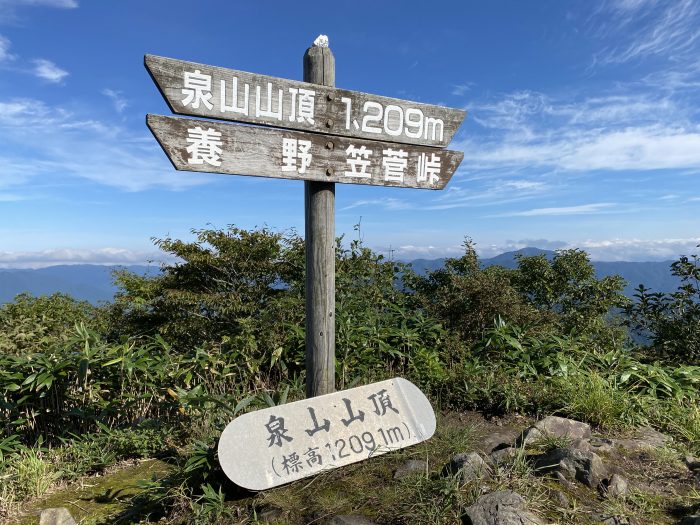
left=144, top=55, right=465, bottom=147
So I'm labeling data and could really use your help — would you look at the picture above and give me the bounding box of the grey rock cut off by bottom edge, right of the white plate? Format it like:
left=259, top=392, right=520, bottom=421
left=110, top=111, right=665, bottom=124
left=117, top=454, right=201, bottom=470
left=464, top=490, right=545, bottom=525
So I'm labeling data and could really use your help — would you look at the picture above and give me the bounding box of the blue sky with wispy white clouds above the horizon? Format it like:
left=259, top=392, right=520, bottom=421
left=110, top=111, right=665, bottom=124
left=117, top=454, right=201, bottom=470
left=0, top=0, right=700, bottom=267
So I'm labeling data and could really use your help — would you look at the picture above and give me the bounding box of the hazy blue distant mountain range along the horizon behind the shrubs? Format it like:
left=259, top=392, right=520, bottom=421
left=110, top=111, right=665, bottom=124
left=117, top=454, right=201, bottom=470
left=0, top=248, right=679, bottom=304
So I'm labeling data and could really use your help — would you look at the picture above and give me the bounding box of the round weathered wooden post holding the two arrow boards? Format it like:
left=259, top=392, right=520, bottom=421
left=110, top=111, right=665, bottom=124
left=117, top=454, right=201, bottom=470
left=304, top=41, right=335, bottom=397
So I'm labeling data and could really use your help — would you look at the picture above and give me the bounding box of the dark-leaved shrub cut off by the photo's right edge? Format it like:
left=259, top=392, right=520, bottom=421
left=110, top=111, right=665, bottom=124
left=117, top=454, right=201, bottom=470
left=627, top=245, right=700, bottom=365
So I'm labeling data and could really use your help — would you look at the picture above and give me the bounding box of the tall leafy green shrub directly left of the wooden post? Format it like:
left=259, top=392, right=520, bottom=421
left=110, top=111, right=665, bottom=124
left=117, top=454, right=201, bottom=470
left=110, top=226, right=304, bottom=386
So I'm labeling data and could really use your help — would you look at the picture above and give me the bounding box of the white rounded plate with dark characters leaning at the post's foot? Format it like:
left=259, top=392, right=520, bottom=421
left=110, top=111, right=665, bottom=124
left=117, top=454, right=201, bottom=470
left=219, top=377, right=435, bottom=490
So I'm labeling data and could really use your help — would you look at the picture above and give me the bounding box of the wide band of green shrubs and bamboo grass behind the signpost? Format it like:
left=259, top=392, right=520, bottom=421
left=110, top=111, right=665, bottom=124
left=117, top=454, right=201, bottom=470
left=0, top=227, right=700, bottom=523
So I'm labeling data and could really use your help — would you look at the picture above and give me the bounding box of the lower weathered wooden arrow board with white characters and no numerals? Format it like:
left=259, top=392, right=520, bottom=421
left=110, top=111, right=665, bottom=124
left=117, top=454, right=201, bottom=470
left=146, top=115, right=464, bottom=190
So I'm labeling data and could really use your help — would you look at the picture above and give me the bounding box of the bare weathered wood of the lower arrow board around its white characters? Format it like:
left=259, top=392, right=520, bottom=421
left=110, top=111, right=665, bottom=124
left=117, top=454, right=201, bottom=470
left=146, top=115, right=464, bottom=190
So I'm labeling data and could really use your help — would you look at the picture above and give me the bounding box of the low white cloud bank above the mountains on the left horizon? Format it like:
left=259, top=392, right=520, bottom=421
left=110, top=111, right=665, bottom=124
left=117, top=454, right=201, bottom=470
left=0, top=248, right=175, bottom=268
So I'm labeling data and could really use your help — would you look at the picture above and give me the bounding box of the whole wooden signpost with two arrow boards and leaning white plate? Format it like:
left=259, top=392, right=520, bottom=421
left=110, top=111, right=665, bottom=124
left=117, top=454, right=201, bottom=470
left=144, top=35, right=465, bottom=489
